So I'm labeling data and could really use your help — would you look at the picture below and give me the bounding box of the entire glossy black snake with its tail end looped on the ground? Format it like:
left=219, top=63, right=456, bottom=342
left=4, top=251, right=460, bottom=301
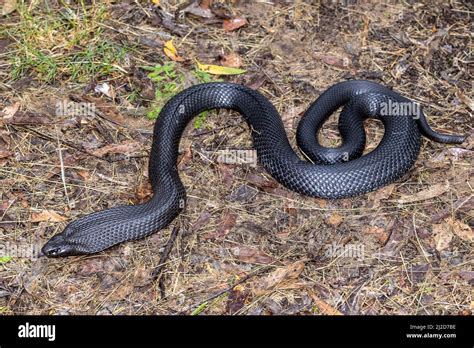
left=42, top=80, right=464, bottom=257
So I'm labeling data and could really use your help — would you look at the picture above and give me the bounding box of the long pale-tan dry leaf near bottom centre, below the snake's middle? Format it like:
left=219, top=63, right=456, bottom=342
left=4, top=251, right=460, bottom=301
left=252, top=261, right=304, bottom=296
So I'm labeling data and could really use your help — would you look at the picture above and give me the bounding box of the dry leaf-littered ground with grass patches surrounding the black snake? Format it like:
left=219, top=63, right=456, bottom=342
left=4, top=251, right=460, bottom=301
left=0, top=0, right=474, bottom=315
